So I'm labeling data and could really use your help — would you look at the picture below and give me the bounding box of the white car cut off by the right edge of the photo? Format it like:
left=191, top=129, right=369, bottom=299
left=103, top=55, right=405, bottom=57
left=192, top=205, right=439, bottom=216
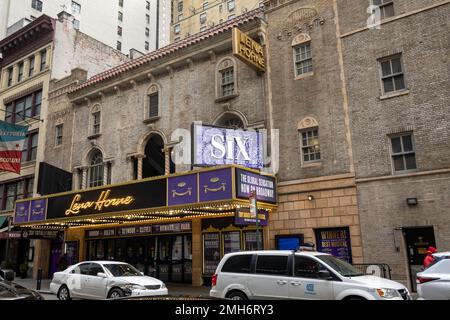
left=417, top=252, right=450, bottom=300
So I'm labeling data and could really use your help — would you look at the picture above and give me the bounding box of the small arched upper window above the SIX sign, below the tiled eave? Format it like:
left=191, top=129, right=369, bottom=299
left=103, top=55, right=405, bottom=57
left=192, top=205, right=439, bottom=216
left=216, top=58, right=238, bottom=99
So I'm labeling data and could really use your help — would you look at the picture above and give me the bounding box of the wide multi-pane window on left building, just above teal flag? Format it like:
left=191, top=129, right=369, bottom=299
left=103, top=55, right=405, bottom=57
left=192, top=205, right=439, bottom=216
left=5, top=90, right=42, bottom=123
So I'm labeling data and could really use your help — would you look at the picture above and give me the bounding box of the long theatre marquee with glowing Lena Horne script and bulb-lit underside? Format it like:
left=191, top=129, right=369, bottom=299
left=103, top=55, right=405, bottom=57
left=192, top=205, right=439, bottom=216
left=14, top=165, right=277, bottom=229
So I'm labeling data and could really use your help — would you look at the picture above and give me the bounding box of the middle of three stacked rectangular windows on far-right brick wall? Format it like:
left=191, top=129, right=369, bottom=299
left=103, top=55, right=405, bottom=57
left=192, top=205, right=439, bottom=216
left=380, top=55, right=406, bottom=94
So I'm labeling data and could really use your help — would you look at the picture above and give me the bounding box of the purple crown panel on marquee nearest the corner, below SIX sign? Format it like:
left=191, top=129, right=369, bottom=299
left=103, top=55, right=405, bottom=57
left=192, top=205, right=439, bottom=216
left=199, top=168, right=233, bottom=202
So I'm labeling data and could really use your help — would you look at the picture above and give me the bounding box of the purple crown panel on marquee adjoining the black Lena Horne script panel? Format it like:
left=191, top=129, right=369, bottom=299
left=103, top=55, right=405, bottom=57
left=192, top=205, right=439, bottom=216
left=167, top=174, right=198, bottom=206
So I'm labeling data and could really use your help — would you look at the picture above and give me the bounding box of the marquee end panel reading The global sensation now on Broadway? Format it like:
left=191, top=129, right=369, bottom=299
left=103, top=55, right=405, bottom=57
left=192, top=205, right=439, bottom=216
left=236, top=169, right=277, bottom=203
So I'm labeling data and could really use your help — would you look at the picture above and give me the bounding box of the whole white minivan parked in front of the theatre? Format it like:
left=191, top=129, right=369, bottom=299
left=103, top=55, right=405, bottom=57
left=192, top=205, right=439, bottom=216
left=210, top=251, right=411, bottom=300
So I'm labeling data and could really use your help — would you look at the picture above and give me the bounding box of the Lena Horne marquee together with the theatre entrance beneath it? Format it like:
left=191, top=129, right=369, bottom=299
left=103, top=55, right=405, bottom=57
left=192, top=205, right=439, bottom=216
left=14, top=165, right=276, bottom=285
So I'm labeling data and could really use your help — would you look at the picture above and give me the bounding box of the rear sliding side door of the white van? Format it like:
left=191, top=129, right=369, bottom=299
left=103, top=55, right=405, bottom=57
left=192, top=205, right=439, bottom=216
left=248, top=254, right=291, bottom=299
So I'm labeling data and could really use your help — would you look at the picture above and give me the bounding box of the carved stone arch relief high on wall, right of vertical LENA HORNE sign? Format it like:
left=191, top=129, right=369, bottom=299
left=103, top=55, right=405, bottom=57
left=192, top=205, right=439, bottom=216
left=277, top=8, right=325, bottom=41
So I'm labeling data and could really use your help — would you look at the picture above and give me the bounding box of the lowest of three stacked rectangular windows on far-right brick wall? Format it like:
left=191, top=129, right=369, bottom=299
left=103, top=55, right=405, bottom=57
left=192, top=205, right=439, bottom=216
left=391, top=133, right=417, bottom=172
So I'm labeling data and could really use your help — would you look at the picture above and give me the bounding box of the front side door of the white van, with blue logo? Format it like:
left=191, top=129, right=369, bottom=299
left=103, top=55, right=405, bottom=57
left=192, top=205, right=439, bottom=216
left=289, top=255, right=334, bottom=300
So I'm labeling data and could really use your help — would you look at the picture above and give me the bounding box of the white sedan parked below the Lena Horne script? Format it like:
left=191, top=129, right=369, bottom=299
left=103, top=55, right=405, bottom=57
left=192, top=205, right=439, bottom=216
left=50, top=261, right=168, bottom=300
